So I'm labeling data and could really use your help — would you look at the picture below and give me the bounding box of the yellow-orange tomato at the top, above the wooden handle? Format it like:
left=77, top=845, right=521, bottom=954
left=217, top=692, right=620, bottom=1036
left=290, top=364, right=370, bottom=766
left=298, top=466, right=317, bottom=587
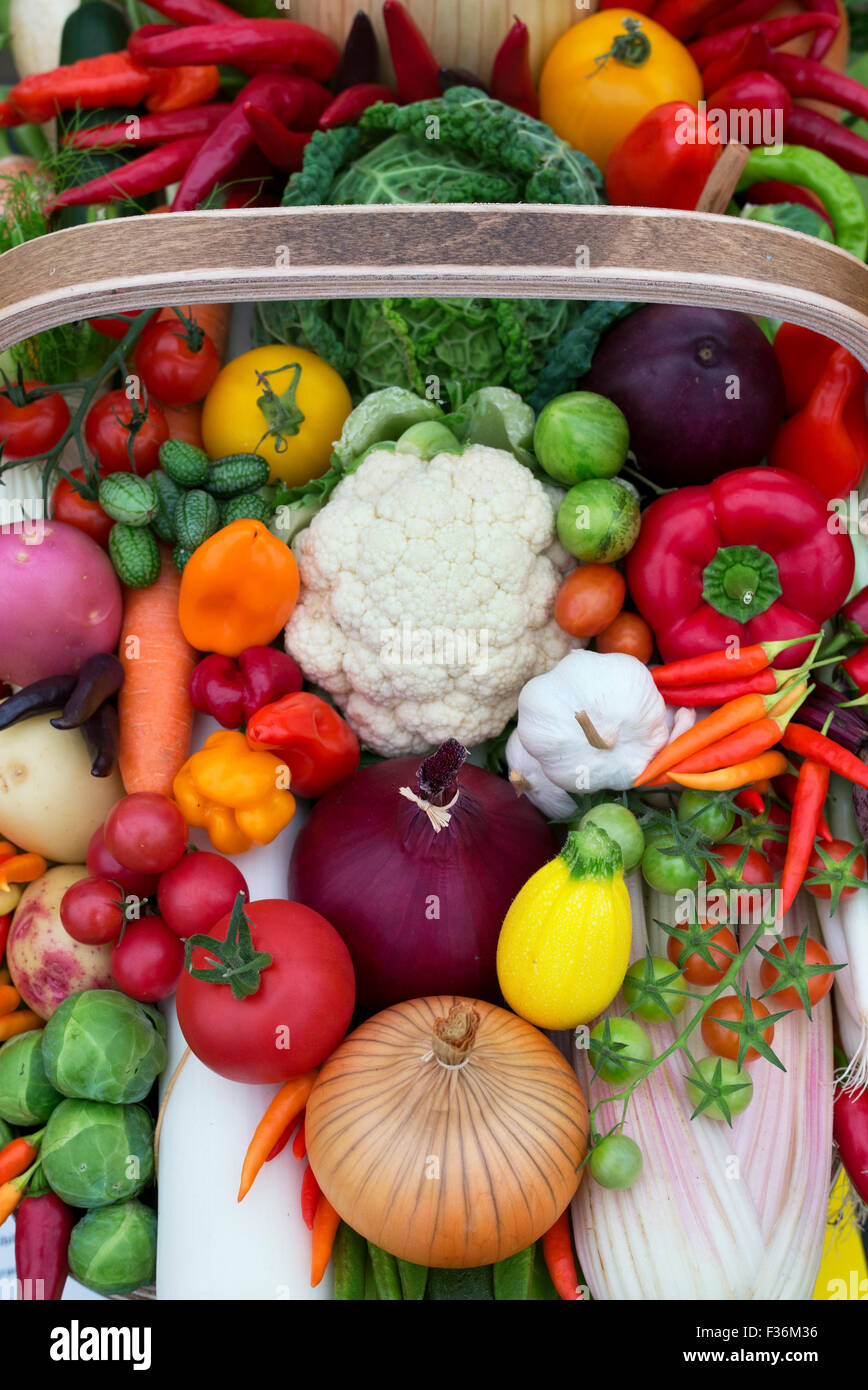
left=540, top=10, right=702, bottom=172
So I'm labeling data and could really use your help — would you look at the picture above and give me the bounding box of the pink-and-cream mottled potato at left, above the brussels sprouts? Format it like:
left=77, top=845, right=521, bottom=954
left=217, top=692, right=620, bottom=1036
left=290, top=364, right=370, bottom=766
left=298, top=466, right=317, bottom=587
left=6, top=865, right=115, bottom=1019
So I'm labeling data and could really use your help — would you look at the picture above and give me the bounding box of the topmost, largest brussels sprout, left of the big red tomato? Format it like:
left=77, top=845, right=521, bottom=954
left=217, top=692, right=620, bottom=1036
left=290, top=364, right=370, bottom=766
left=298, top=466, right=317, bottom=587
left=42, top=990, right=167, bottom=1105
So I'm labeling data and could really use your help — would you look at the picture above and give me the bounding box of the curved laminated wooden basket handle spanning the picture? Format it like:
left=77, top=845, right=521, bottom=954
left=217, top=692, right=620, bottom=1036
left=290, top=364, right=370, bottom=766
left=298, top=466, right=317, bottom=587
left=0, top=203, right=868, bottom=367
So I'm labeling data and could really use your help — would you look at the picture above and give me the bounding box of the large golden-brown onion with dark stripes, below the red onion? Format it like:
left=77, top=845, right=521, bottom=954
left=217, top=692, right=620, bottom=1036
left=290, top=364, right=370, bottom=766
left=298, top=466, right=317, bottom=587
left=305, top=995, right=588, bottom=1269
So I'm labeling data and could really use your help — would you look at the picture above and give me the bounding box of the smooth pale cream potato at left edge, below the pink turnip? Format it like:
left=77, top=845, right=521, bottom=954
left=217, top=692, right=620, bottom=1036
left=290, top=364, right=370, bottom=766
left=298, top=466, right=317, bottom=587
left=0, top=714, right=124, bottom=865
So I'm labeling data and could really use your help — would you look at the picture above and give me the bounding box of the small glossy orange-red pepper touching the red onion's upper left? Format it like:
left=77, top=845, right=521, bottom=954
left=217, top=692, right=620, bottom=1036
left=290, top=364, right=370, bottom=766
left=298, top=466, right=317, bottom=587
left=248, top=691, right=359, bottom=796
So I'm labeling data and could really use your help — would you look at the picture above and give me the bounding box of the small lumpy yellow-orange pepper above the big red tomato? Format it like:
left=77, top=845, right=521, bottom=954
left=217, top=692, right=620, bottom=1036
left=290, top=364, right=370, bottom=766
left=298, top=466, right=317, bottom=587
left=172, top=730, right=295, bottom=855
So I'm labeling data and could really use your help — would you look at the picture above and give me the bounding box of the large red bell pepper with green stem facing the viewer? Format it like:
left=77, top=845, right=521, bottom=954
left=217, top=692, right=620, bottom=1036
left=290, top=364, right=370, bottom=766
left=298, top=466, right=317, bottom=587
left=626, top=467, right=854, bottom=669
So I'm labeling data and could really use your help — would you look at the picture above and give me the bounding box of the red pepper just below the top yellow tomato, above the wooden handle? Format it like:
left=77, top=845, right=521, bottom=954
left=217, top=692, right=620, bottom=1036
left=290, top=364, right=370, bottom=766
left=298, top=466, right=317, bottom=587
left=606, top=101, right=722, bottom=211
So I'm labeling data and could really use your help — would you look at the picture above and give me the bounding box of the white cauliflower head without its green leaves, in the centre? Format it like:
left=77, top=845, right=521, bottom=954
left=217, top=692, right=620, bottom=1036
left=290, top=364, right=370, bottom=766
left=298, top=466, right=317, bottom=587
left=287, top=445, right=579, bottom=758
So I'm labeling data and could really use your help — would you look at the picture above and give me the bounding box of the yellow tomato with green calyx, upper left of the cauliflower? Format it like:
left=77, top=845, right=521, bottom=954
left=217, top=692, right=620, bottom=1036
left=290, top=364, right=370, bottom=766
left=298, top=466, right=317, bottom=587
left=202, top=345, right=352, bottom=487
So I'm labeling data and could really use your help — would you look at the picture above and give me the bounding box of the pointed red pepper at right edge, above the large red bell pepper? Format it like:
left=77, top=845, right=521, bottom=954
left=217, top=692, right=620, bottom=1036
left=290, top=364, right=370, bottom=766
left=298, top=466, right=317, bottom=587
left=769, top=348, right=868, bottom=498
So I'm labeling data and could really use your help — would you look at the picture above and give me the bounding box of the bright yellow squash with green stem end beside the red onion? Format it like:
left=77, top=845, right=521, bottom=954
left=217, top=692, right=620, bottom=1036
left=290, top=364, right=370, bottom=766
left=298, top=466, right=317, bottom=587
left=497, top=824, right=632, bottom=1029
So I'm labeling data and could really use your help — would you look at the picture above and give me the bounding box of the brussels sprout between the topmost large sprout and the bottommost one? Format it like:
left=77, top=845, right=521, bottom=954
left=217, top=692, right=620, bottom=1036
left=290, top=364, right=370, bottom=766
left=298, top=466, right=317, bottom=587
left=42, top=1101, right=153, bottom=1207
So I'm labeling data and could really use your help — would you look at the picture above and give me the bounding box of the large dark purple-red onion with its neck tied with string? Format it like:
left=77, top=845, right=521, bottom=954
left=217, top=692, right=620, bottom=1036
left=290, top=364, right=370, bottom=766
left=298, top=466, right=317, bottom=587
left=289, top=738, right=558, bottom=1009
